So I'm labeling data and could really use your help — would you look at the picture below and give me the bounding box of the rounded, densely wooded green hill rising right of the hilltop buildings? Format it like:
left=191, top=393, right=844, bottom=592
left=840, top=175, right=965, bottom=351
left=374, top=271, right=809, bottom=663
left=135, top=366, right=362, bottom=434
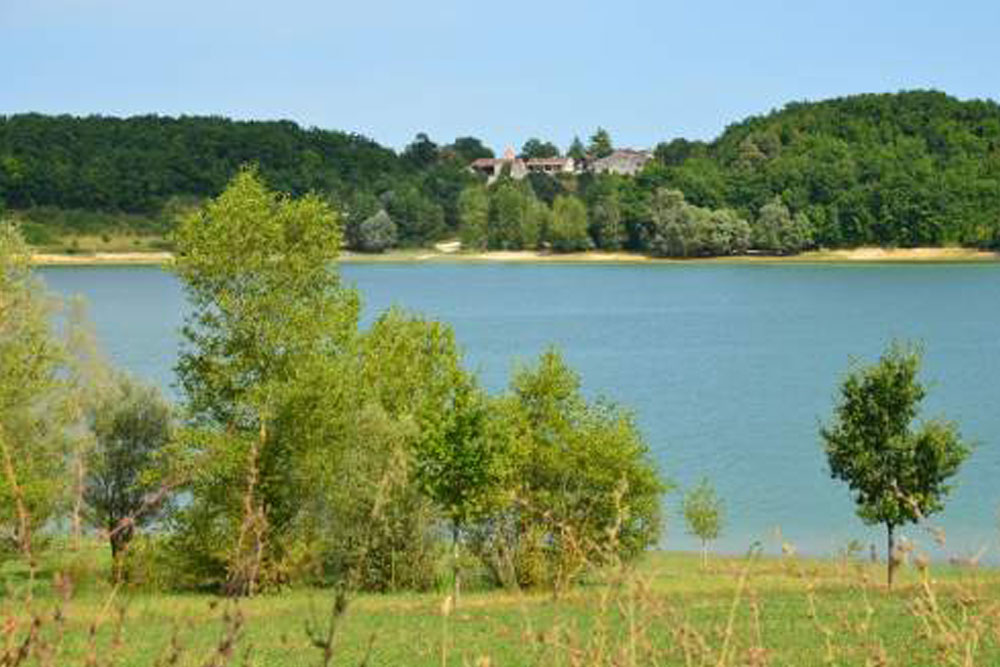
left=657, top=91, right=1000, bottom=247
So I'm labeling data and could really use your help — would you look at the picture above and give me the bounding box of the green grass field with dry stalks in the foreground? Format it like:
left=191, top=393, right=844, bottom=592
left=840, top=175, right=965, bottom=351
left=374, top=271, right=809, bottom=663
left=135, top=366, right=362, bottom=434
left=0, top=552, right=1000, bottom=667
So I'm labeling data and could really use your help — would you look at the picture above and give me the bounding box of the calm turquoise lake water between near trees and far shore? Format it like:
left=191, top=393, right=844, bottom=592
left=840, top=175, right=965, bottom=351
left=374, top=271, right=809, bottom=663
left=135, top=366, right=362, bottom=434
left=41, top=264, right=1000, bottom=562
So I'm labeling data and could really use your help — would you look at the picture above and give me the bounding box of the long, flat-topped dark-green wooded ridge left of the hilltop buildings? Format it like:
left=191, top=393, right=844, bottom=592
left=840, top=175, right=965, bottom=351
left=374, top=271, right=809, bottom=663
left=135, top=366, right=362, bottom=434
left=0, top=114, right=402, bottom=213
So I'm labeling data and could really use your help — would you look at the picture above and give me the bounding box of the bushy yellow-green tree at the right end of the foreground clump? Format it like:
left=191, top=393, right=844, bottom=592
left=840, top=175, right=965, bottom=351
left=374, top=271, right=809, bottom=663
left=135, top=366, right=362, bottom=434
left=473, top=351, right=669, bottom=586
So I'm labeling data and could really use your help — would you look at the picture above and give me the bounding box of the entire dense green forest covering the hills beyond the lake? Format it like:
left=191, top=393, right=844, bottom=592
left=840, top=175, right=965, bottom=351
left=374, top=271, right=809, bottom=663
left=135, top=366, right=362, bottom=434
left=0, top=91, right=1000, bottom=252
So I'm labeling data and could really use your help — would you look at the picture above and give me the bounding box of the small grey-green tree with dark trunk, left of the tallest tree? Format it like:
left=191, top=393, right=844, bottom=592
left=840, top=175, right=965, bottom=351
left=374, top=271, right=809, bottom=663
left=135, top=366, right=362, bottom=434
left=84, top=373, right=173, bottom=562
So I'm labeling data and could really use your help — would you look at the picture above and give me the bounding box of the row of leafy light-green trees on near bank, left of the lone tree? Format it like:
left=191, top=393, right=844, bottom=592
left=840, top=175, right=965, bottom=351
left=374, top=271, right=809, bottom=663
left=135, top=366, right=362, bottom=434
left=0, top=170, right=667, bottom=595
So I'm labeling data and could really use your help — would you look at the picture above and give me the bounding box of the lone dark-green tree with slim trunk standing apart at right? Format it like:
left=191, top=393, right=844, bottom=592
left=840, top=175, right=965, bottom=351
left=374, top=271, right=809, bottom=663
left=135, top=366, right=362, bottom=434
left=820, top=342, right=970, bottom=587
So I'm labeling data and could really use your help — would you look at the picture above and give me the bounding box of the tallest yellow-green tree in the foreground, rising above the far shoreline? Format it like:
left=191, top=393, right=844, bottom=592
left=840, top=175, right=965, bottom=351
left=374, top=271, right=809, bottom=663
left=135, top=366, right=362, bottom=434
left=175, top=169, right=358, bottom=593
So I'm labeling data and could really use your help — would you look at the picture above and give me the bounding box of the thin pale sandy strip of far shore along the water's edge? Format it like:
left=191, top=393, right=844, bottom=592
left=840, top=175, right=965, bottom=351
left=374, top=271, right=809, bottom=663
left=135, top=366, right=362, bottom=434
left=32, top=244, right=1000, bottom=266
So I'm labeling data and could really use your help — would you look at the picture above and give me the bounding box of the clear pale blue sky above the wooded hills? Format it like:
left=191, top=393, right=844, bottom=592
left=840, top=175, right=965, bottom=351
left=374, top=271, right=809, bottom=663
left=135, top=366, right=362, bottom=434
left=0, top=0, right=1000, bottom=150
